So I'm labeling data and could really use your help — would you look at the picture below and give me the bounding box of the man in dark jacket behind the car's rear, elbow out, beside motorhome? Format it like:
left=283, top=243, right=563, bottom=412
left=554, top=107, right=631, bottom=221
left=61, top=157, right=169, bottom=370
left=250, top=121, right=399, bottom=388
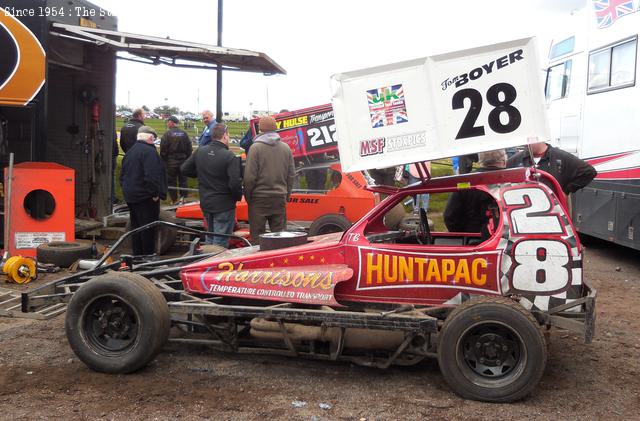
left=507, top=142, right=598, bottom=194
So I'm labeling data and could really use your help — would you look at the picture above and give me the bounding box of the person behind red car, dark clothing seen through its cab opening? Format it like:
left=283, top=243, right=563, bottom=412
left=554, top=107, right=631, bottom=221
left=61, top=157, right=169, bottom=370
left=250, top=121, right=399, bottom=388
left=443, top=149, right=507, bottom=239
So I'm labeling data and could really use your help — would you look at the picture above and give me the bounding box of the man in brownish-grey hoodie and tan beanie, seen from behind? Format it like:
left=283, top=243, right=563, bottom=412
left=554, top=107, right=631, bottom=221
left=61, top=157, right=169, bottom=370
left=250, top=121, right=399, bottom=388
left=244, top=116, right=295, bottom=243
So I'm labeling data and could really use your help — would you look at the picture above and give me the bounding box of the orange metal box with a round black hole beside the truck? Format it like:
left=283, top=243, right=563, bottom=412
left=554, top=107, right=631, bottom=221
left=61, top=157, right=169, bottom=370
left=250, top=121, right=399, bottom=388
left=4, top=162, right=75, bottom=257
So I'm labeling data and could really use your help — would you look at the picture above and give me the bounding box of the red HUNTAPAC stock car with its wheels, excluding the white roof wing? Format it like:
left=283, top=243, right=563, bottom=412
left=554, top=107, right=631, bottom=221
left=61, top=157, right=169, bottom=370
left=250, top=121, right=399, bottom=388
left=23, top=169, right=595, bottom=402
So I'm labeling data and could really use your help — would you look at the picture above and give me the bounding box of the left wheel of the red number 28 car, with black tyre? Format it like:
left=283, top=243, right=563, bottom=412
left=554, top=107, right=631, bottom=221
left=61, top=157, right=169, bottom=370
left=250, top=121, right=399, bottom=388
left=65, top=272, right=171, bottom=374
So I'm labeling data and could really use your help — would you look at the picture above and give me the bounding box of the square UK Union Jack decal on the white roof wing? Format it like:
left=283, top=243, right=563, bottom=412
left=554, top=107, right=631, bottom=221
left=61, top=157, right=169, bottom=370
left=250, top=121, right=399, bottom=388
left=367, top=84, right=409, bottom=128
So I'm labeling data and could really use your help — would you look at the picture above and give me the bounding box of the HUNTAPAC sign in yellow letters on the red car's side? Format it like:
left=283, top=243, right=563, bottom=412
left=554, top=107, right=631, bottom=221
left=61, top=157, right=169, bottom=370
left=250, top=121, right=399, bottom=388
left=358, top=247, right=498, bottom=292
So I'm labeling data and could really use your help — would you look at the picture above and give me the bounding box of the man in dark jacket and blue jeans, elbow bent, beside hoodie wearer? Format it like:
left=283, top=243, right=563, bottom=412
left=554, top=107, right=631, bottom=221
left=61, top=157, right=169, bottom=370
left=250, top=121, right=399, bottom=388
left=181, top=124, right=242, bottom=247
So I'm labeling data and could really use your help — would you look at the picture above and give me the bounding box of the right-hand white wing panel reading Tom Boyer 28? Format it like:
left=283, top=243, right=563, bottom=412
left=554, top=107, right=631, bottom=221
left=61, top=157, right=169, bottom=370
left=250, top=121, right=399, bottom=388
left=432, top=39, right=546, bottom=150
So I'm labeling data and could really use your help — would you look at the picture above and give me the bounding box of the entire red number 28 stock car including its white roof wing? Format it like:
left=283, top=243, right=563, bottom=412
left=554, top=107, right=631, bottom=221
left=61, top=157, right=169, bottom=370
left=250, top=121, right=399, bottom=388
left=22, top=39, right=596, bottom=402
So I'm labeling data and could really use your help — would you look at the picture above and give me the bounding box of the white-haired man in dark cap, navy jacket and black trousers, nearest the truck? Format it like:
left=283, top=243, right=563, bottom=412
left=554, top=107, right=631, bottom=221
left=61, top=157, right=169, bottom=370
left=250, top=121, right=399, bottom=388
left=120, top=126, right=167, bottom=255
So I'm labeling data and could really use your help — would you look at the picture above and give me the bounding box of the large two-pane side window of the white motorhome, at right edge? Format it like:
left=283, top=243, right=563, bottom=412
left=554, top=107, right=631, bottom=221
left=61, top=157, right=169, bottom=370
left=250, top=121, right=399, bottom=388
left=587, top=39, right=638, bottom=93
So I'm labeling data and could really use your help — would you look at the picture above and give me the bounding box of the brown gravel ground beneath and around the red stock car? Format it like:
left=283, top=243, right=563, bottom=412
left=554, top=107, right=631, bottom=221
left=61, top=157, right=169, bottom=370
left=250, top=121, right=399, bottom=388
left=0, top=236, right=640, bottom=420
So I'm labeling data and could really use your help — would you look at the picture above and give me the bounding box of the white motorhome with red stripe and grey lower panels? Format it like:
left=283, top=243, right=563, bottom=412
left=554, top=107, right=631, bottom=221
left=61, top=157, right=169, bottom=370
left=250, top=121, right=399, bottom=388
left=545, top=6, right=640, bottom=249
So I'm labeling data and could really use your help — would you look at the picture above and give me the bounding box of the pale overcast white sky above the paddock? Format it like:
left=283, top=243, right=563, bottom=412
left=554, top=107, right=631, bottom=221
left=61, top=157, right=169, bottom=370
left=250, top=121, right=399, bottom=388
left=92, top=0, right=587, bottom=114
